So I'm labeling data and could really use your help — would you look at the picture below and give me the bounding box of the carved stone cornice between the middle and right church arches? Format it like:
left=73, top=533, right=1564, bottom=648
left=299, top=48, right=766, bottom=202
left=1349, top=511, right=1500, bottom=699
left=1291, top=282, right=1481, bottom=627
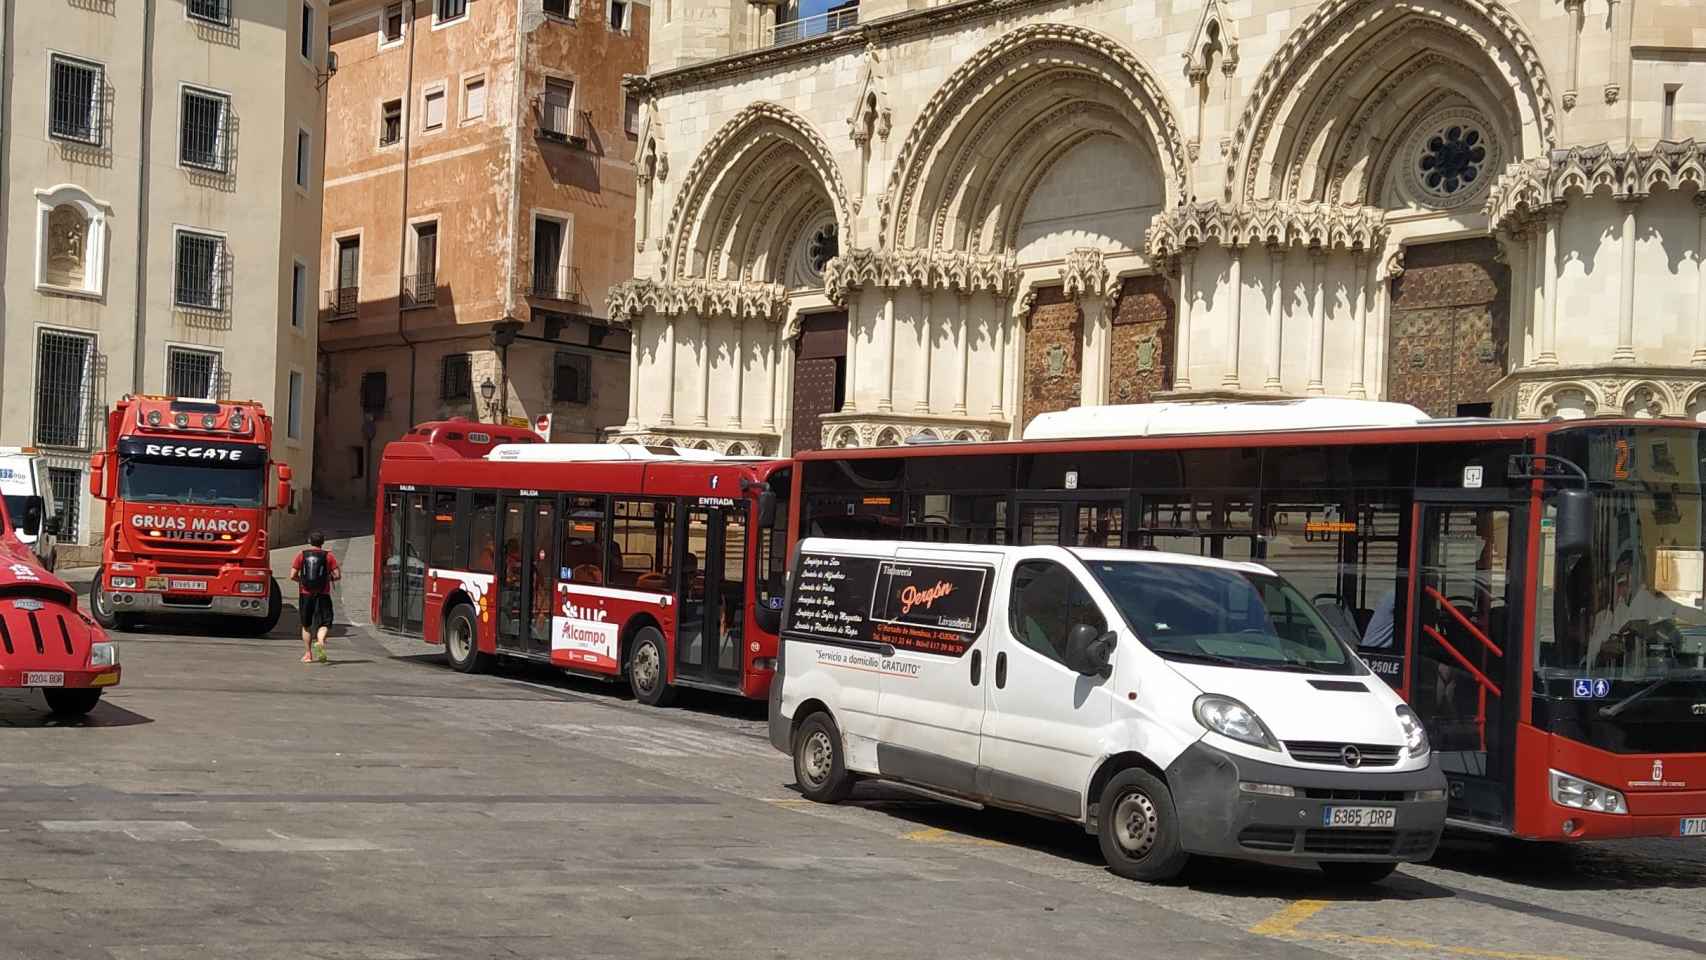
left=1145, top=200, right=1387, bottom=261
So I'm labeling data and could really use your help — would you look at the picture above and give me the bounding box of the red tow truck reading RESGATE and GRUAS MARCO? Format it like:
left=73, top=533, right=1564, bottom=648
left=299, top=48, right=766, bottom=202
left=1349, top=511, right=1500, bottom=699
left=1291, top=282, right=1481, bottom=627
left=89, top=396, right=290, bottom=636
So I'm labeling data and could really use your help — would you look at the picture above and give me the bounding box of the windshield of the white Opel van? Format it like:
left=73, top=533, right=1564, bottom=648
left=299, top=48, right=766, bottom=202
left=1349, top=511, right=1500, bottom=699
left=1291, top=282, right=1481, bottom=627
left=1087, top=561, right=1363, bottom=674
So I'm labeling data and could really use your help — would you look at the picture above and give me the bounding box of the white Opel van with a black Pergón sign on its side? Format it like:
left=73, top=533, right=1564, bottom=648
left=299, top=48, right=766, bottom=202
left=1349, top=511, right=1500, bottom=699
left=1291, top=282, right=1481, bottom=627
left=769, top=539, right=1445, bottom=882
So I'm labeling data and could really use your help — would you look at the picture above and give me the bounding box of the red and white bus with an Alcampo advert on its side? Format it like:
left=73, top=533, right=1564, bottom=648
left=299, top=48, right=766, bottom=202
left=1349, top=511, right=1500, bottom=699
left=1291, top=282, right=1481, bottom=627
left=374, top=421, right=792, bottom=706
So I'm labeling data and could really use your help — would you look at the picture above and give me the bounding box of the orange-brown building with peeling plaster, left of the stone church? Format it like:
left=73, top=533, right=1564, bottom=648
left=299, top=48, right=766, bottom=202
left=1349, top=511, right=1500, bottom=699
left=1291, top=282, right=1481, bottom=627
left=316, top=0, right=647, bottom=501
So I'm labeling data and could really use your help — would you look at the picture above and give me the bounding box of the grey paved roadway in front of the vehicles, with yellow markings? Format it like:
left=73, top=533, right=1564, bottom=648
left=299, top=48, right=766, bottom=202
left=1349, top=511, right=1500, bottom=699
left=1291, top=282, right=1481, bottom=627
left=0, top=603, right=1706, bottom=960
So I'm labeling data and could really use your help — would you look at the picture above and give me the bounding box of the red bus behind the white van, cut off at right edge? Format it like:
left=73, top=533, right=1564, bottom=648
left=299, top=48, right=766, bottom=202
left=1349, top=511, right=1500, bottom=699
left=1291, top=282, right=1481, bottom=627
left=793, top=401, right=1706, bottom=842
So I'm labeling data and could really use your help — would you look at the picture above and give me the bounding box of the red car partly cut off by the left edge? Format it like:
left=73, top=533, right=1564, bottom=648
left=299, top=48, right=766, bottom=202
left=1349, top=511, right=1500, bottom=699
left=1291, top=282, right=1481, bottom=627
left=0, top=494, right=119, bottom=716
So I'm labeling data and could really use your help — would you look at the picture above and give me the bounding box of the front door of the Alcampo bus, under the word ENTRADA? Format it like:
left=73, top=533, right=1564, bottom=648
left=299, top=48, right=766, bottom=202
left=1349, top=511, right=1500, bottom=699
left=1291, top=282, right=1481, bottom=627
left=676, top=498, right=749, bottom=687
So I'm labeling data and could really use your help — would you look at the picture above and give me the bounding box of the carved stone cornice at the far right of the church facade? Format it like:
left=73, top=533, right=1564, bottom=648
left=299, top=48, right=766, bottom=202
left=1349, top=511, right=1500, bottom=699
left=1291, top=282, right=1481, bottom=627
left=1483, top=140, right=1706, bottom=232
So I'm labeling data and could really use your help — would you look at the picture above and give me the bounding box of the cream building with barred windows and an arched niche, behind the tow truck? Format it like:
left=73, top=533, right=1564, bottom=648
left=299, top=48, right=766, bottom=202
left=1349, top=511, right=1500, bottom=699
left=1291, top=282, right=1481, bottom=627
left=0, top=0, right=328, bottom=563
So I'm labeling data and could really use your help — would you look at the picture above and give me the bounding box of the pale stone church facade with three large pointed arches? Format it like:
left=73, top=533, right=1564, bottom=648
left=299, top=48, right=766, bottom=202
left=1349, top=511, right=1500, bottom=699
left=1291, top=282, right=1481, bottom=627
left=611, top=0, right=1706, bottom=452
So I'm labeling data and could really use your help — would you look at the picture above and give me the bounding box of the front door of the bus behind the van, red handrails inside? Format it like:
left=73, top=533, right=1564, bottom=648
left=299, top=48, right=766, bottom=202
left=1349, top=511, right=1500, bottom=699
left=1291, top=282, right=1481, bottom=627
left=1407, top=501, right=1525, bottom=827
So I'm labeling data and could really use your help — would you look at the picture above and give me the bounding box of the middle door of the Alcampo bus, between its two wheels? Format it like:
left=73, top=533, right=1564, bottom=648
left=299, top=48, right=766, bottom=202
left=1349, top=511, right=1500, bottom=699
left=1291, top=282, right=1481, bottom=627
left=498, top=496, right=556, bottom=656
